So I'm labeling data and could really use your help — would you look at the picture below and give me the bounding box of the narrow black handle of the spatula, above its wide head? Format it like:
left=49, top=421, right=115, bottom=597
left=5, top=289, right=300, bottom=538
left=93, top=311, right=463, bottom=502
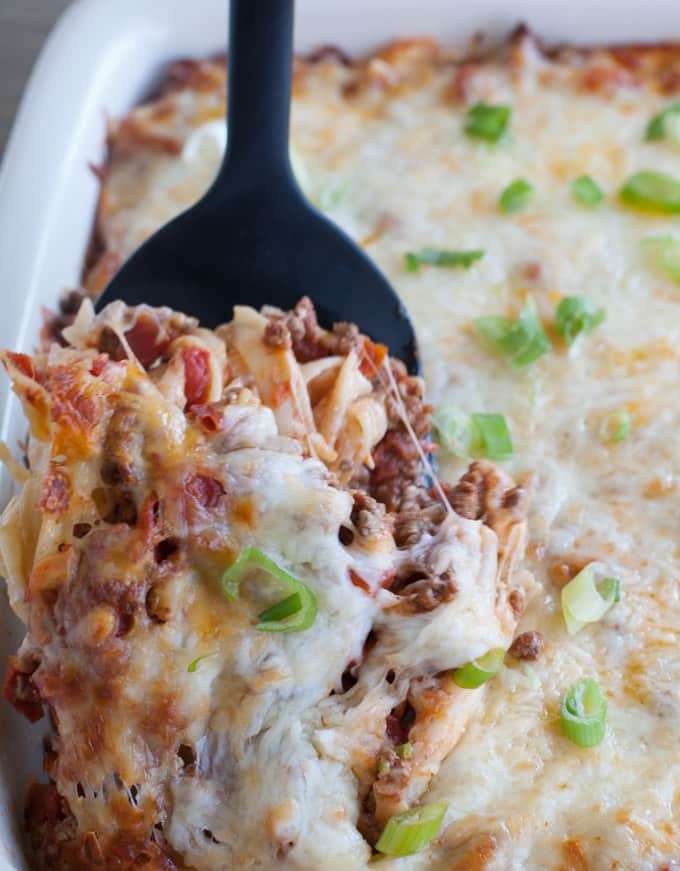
left=220, top=0, right=295, bottom=187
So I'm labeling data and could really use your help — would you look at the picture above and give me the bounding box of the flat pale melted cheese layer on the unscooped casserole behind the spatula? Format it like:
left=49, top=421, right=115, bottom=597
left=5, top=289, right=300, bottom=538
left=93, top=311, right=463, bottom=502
left=94, top=35, right=680, bottom=871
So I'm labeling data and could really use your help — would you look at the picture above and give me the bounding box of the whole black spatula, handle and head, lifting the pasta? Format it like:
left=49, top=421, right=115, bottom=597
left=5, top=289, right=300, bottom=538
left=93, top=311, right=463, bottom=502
left=97, top=0, right=418, bottom=372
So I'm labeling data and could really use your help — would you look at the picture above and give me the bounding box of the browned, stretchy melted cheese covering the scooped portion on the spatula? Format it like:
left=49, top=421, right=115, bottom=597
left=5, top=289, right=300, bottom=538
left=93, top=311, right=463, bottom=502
left=0, top=303, right=530, bottom=871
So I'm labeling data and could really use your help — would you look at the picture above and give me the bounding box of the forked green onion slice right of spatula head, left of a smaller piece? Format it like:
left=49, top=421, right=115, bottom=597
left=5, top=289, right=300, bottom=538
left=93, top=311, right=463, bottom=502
left=472, top=297, right=551, bottom=367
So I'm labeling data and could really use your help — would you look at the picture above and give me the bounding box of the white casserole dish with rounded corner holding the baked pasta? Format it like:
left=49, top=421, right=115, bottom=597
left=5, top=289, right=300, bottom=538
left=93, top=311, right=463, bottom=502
left=0, top=0, right=680, bottom=871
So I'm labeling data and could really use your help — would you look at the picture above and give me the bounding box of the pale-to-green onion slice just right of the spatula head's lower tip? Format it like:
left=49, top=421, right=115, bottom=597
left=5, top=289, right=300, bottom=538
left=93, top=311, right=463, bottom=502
left=432, top=404, right=513, bottom=460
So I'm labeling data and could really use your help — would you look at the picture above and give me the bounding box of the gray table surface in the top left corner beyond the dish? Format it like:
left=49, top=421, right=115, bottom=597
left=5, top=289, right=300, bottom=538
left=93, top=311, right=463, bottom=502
left=0, top=0, right=71, bottom=155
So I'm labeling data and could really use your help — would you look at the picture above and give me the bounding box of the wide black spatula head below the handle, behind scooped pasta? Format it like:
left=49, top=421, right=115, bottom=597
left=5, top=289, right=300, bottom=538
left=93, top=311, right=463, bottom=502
left=97, top=185, right=419, bottom=372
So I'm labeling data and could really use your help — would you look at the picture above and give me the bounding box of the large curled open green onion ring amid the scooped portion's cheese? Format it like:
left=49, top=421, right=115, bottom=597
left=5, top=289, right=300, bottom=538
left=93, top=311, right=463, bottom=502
left=221, top=547, right=317, bottom=632
